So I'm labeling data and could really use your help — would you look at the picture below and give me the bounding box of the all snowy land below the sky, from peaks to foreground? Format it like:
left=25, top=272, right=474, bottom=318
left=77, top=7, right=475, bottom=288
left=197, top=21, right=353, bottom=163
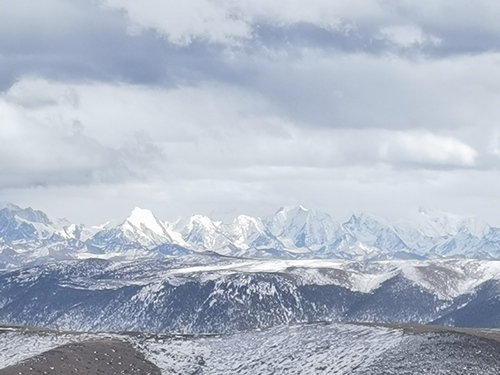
left=0, top=204, right=500, bottom=374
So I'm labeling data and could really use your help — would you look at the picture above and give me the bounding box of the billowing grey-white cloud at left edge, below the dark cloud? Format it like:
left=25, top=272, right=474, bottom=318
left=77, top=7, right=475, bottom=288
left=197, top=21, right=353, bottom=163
left=0, top=86, right=166, bottom=189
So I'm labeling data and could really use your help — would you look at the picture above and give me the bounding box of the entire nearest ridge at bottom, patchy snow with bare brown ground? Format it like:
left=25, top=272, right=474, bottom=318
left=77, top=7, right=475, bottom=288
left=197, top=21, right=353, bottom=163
left=0, top=324, right=500, bottom=375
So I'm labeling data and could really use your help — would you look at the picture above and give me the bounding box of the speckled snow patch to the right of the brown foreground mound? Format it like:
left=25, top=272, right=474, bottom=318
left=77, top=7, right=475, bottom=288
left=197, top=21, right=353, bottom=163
left=141, top=324, right=403, bottom=375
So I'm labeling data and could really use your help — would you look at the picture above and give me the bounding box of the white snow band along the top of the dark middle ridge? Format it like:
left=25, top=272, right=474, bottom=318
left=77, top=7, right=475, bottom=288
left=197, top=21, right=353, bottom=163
left=169, top=259, right=500, bottom=300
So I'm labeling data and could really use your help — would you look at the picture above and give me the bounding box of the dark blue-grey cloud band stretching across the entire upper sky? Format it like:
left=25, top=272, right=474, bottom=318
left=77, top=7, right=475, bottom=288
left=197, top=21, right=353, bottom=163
left=0, top=0, right=500, bottom=95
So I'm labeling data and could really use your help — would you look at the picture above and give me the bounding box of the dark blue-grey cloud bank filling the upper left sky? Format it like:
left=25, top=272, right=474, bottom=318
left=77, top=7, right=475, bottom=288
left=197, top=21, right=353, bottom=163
left=0, top=1, right=252, bottom=91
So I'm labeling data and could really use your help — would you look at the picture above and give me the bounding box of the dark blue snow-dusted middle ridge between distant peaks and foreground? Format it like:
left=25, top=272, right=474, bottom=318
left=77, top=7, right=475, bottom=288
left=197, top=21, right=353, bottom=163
left=0, top=255, right=500, bottom=333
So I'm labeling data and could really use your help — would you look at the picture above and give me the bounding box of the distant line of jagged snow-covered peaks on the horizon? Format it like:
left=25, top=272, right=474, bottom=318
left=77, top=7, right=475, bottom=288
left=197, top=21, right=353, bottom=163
left=0, top=204, right=500, bottom=269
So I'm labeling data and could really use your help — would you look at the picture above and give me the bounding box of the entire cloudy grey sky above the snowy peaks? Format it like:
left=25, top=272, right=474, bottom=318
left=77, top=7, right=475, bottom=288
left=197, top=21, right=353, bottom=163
left=0, top=0, right=500, bottom=225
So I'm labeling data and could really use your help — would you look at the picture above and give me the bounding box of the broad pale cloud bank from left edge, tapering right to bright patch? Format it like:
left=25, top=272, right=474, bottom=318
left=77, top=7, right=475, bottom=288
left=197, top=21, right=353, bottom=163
left=0, top=75, right=478, bottom=191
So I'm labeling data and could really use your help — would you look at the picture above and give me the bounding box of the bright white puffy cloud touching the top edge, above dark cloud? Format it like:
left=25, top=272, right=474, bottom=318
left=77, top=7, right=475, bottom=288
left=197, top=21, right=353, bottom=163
left=97, top=0, right=388, bottom=45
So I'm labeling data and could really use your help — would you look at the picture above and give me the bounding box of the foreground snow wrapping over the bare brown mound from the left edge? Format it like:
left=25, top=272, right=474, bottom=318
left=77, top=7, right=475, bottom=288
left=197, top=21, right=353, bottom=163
left=0, top=324, right=403, bottom=375
